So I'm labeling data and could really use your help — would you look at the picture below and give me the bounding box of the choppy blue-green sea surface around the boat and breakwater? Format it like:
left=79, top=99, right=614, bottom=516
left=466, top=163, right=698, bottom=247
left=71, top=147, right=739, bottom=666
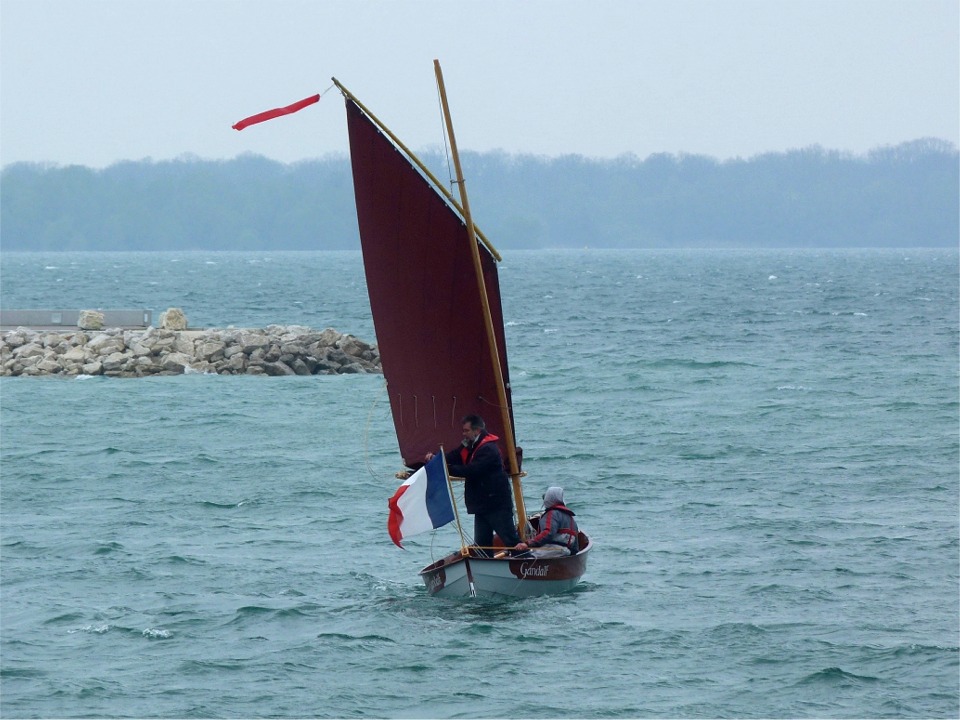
left=0, top=249, right=960, bottom=718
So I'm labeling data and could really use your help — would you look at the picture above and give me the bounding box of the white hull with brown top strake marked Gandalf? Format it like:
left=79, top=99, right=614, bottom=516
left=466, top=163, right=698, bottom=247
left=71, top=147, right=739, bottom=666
left=420, top=533, right=592, bottom=598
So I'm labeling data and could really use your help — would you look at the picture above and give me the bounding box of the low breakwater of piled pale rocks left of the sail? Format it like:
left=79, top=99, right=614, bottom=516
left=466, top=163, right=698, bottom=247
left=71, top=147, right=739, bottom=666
left=0, top=325, right=381, bottom=377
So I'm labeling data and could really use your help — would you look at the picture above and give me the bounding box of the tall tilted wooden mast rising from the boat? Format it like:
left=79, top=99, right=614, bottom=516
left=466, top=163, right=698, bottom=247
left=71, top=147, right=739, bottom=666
left=433, top=60, right=527, bottom=540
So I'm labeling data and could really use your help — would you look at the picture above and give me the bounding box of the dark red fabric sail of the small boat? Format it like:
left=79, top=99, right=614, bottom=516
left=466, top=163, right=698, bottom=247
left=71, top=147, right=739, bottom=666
left=346, top=98, right=512, bottom=466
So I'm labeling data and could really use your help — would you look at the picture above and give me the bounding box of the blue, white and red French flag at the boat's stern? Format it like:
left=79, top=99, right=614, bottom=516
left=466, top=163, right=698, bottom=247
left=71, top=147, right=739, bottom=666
left=387, top=452, right=453, bottom=548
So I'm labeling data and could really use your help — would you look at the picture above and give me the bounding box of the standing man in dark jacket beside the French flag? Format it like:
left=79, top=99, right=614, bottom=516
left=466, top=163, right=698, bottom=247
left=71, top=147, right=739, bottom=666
left=425, top=415, right=520, bottom=555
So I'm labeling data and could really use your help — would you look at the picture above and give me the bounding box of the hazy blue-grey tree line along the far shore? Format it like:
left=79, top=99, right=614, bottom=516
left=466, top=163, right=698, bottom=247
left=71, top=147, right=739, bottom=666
left=0, top=139, right=960, bottom=250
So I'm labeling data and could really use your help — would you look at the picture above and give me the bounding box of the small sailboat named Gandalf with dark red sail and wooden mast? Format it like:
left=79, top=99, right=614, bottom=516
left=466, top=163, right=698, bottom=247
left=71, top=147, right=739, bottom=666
left=333, top=61, right=591, bottom=597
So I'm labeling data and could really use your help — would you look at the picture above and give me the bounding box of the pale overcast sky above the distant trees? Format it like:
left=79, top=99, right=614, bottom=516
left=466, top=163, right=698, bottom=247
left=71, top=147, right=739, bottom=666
left=0, top=0, right=960, bottom=167
